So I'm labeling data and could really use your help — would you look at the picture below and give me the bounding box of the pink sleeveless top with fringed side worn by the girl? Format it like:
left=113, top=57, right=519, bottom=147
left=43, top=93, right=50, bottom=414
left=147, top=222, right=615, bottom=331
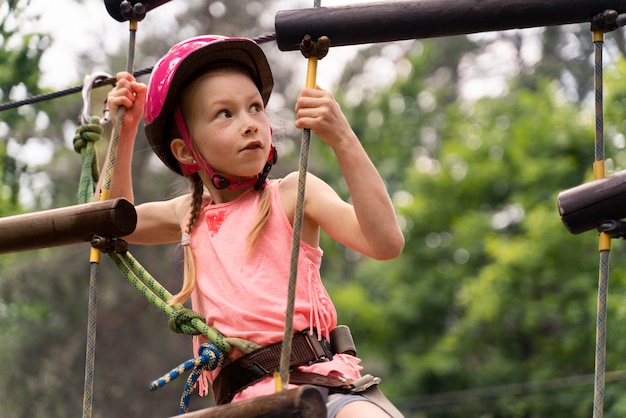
left=181, top=180, right=361, bottom=401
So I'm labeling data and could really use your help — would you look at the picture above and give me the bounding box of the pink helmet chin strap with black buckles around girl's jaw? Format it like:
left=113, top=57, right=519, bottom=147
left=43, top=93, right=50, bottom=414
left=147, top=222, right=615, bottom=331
left=174, top=107, right=278, bottom=190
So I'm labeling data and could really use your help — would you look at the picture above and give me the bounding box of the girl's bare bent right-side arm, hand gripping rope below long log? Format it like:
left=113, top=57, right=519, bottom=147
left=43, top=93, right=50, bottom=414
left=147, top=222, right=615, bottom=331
left=296, top=88, right=404, bottom=259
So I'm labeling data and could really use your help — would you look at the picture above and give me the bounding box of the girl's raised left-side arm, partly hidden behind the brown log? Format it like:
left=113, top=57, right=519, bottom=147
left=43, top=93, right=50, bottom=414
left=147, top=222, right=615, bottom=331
left=96, top=72, right=182, bottom=244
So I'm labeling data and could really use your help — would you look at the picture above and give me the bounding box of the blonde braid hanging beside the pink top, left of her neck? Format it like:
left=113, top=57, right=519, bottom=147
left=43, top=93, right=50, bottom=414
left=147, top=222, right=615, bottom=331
left=169, top=173, right=204, bottom=305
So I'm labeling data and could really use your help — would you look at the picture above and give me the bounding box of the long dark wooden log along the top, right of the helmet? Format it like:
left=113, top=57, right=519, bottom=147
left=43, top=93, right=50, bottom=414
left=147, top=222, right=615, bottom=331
left=275, top=0, right=626, bottom=51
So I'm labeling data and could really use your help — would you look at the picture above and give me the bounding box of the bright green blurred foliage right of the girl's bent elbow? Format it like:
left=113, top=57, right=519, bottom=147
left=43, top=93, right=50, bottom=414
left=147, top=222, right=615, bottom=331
left=320, top=37, right=626, bottom=417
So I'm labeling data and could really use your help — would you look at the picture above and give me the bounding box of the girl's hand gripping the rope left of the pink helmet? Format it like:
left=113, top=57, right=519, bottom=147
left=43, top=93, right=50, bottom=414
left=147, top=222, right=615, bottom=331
left=107, top=72, right=147, bottom=129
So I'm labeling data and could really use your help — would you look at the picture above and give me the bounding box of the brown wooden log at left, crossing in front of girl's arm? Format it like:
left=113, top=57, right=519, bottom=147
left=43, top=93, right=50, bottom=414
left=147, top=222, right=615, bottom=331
left=0, top=198, right=137, bottom=254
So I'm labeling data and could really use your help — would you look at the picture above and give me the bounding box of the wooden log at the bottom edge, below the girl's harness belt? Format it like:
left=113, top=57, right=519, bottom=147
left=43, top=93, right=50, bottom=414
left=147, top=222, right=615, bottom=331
left=173, top=385, right=326, bottom=418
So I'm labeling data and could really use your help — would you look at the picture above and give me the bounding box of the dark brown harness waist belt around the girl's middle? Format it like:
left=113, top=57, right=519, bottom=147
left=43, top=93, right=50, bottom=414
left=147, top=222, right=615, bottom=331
left=213, top=330, right=333, bottom=405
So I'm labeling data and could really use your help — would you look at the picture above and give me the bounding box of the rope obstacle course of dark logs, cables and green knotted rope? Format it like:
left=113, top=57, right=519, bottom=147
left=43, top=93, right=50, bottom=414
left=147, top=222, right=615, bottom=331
left=0, top=0, right=626, bottom=418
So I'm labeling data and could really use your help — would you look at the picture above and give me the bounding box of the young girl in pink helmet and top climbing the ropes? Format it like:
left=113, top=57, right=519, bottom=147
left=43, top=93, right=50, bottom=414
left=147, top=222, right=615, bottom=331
left=102, top=36, right=404, bottom=418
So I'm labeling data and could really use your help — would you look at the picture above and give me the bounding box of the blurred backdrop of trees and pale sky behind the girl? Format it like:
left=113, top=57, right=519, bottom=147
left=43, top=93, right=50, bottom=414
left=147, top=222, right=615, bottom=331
left=0, top=0, right=626, bottom=418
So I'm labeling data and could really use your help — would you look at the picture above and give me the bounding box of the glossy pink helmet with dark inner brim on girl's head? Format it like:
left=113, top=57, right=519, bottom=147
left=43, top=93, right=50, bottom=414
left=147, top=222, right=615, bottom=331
left=144, top=35, right=274, bottom=174
